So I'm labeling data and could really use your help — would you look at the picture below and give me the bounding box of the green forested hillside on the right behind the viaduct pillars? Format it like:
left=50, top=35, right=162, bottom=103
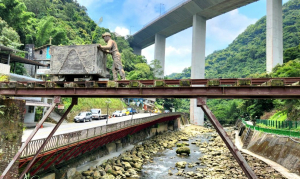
left=167, top=0, right=300, bottom=123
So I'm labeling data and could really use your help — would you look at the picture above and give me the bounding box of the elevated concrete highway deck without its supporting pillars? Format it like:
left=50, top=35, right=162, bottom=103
left=131, top=0, right=258, bottom=49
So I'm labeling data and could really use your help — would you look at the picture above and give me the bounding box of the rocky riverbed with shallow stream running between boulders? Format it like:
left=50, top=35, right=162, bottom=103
left=74, top=125, right=284, bottom=179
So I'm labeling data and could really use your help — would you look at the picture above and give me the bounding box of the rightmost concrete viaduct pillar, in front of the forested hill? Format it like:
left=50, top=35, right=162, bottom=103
left=267, top=0, right=283, bottom=73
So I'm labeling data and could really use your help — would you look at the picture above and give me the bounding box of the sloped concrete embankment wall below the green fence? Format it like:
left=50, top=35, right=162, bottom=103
left=239, top=121, right=300, bottom=175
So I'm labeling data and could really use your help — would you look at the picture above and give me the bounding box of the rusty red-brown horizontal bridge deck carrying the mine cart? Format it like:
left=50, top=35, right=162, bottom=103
left=0, top=77, right=300, bottom=99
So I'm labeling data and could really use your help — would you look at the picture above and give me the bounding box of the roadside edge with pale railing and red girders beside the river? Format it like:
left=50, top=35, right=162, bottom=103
left=19, top=113, right=181, bottom=176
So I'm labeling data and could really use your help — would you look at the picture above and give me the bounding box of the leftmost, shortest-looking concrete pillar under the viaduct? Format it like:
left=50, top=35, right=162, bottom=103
left=154, top=34, right=166, bottom=79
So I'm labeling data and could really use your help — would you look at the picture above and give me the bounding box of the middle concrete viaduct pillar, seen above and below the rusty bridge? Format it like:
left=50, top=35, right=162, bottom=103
left=190, top=15, right=206, bottom=125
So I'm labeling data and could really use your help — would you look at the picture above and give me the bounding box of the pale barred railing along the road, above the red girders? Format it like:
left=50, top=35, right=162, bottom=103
left=21, top=113, right=181, bottom=158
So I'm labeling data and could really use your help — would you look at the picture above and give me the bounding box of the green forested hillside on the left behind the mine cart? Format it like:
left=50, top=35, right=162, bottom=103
left=0, top=0, right=154, bottom=80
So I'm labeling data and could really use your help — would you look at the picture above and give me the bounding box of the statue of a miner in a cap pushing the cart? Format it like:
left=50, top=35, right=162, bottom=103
left=99, top=32, right=125, bottom=80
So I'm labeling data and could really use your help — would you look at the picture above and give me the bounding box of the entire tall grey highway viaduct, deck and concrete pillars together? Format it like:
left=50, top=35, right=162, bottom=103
left=131, top=0, right=283, bottom=125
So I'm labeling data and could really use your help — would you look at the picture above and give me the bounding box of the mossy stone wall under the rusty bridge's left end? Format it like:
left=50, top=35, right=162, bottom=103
left=0, top=99, right=25, bottom=179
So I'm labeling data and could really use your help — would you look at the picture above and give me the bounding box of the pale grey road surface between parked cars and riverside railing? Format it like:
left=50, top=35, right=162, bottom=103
left=22, top=113, right=157, bottom=142
